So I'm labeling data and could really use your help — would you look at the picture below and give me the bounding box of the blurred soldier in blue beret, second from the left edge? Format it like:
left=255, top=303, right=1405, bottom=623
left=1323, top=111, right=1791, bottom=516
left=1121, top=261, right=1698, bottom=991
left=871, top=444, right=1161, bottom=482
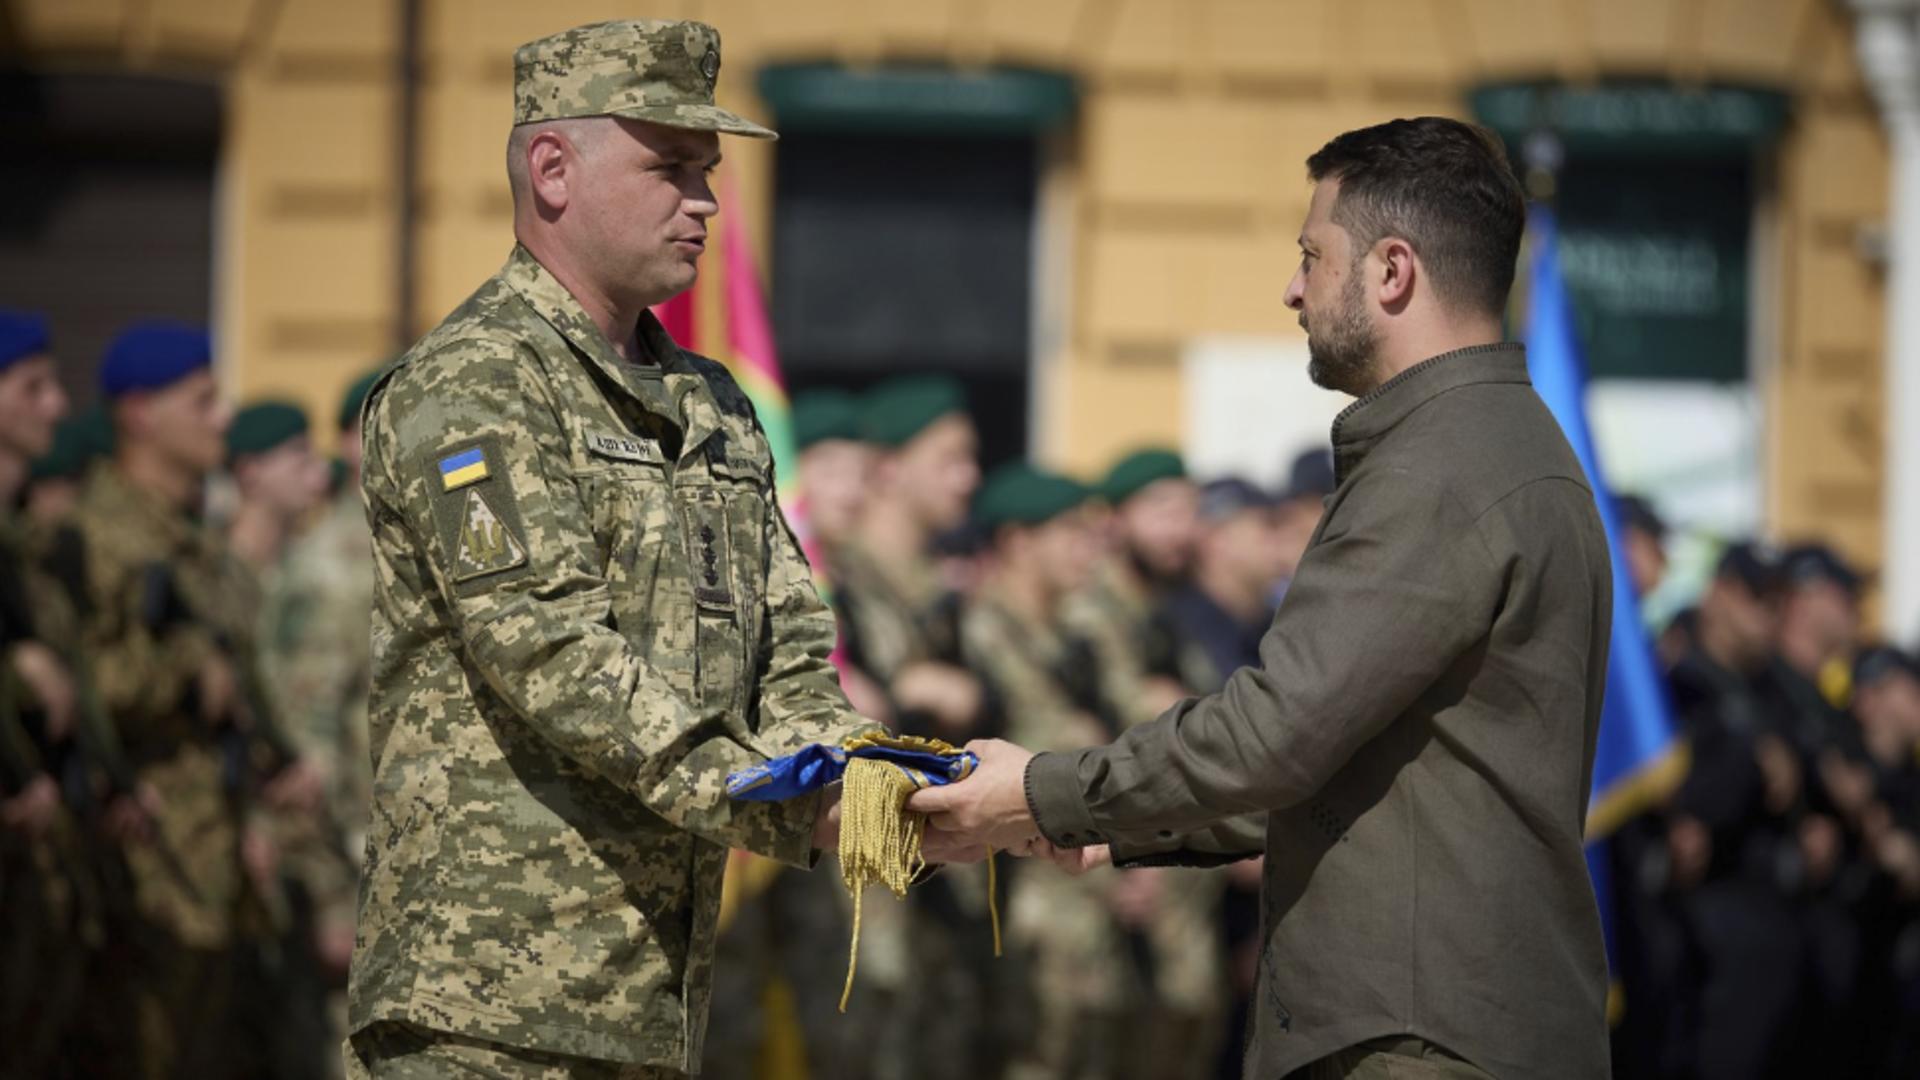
left=75, top=323, right=312, bottom=1076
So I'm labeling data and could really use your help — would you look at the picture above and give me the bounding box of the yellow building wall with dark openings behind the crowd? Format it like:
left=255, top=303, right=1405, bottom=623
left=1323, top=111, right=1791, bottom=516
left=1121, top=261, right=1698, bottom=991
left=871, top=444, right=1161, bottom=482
left=4, top=0, right=1887, bottom=588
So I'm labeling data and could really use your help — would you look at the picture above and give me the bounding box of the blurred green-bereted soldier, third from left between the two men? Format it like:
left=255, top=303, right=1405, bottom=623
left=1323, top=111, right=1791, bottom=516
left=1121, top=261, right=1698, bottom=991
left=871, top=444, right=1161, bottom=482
left=962, top=463, right=1140, bottom=1080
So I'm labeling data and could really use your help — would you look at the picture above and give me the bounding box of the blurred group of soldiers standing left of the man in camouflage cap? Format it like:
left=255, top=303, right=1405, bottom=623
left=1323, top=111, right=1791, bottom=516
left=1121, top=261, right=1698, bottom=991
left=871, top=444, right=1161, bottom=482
left=0, top=311, right=372, bottom=1078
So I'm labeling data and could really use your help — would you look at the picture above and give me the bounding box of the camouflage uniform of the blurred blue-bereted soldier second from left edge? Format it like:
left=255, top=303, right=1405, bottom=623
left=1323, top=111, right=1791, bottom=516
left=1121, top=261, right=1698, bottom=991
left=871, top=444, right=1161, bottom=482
left=75, top=463, right=253, bottom=949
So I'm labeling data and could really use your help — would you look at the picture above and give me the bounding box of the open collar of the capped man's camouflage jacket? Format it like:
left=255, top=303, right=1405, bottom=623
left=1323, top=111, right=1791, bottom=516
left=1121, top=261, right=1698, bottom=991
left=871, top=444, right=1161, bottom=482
left=499, top=244, right=720, bottom=461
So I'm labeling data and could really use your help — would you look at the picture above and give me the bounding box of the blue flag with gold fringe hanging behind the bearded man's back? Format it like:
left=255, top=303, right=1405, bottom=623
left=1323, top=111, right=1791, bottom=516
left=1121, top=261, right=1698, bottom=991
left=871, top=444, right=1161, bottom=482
left=1526, top=206, right=1686, bottom=999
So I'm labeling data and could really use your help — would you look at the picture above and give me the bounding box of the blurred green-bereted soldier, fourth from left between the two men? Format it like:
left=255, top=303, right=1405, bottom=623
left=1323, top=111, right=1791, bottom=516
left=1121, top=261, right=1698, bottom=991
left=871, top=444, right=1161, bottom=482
left=1062, top=450, right=1227, bottom=1080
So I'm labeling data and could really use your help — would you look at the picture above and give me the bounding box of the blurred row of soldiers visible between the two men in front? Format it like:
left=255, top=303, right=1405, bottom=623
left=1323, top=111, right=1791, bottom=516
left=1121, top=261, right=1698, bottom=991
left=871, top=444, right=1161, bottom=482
left=705, top=377, right=1332, bottom=1080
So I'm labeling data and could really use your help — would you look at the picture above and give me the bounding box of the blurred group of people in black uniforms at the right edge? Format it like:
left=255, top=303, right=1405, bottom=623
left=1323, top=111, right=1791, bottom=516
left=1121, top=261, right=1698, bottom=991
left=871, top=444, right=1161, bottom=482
left=1609, top=500, right=1920, bottom=1080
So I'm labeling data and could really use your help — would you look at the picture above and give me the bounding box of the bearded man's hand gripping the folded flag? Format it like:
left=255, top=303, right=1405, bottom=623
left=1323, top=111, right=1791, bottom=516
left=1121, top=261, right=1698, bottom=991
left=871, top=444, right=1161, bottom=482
left=906, top=738, right=1043, bottom=863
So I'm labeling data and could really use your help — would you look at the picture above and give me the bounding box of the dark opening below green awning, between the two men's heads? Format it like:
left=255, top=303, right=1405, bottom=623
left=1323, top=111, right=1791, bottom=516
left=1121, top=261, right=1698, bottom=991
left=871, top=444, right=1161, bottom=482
left=772, top=131, right=1041, bottom=467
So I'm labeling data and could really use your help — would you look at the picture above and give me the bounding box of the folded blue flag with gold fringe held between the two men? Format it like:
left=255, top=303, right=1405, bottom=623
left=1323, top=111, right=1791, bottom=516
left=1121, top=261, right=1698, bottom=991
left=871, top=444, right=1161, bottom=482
left=726, top=732, right=1000, bottom=1013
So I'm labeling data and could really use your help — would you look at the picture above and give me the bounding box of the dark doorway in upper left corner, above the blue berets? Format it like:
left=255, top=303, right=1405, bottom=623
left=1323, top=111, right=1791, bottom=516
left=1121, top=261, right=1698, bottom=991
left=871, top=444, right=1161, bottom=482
left=0, top=71, right=221, bottom=405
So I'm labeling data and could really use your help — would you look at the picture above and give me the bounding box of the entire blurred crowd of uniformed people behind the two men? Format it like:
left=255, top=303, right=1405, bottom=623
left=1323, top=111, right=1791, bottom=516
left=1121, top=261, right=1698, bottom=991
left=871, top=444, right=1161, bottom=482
left=0, top=305, right=1920, bottom=1080
